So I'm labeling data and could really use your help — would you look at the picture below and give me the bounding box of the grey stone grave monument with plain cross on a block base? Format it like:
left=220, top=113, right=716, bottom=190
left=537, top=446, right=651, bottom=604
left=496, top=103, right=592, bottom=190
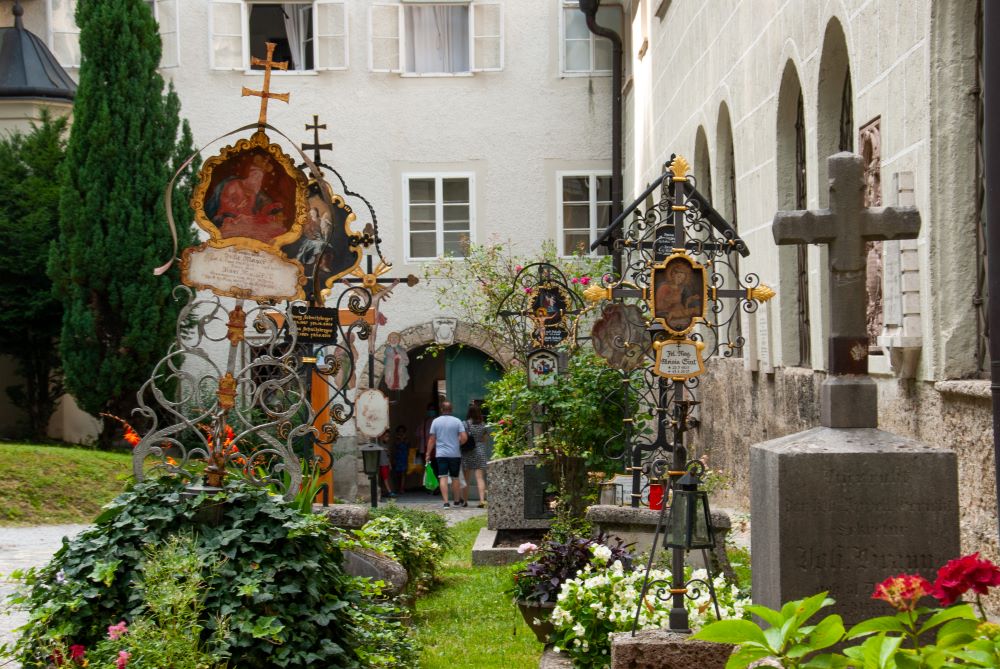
left=750, top=153, right=960, bottom=625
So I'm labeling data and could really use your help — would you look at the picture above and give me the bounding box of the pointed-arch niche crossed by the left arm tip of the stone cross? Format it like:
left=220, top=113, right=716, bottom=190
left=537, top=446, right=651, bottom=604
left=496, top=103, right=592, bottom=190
left=772, top=59, right=811, bottom=366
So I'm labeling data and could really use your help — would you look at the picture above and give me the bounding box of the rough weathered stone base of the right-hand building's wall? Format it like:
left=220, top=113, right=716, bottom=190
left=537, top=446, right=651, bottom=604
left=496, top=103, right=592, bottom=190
left=691, top=359, right=1000, bottom=559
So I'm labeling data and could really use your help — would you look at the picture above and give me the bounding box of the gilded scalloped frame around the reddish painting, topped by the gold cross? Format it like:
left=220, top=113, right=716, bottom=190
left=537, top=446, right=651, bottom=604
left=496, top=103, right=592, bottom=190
left=191, top=130, right=309, bottom=252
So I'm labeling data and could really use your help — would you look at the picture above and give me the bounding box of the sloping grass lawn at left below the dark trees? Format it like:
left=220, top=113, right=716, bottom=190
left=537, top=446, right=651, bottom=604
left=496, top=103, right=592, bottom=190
left=0, top=444, right=132, bottom=525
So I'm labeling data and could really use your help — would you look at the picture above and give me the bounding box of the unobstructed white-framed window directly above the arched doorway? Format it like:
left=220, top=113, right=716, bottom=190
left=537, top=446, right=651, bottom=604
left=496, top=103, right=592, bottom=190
left=403, top=173, right=475, bottom=260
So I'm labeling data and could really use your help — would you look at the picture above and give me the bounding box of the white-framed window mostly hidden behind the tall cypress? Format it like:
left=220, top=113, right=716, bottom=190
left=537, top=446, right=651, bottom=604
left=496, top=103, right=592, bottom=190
left=45, top=0, right=180, bottom=68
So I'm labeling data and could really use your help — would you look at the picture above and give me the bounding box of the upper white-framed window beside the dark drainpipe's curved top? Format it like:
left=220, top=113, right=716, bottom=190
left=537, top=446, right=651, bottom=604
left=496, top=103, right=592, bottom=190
left=559, top=0, right=623, bottom=75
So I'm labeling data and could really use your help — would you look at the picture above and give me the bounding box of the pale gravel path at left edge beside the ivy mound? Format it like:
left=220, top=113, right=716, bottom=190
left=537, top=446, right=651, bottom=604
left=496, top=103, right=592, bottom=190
left=0, top=525, right=86, bottom=669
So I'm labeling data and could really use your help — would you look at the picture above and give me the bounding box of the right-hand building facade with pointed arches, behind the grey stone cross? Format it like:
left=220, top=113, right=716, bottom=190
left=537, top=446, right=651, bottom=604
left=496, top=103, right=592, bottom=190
left=625, top=0, right=997, bottom=559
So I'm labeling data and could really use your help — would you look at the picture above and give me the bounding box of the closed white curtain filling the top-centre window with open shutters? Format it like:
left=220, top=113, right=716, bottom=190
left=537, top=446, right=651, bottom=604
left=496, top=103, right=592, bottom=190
left=406, top=7, right=469, bottom=74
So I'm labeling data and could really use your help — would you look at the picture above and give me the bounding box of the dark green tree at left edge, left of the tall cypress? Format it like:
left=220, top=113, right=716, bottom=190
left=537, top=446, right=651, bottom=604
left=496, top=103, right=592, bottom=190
left=0, top=111, right=68, bottom=439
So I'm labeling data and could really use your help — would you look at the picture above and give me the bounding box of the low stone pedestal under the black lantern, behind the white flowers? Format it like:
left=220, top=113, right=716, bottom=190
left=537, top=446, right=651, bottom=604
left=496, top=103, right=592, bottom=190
left=611, top=630, right=734, bottom=669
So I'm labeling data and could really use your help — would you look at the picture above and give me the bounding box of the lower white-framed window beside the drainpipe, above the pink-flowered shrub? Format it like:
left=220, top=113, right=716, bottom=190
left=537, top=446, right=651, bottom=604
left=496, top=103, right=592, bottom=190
left=557, top=170, right=611, bottom=256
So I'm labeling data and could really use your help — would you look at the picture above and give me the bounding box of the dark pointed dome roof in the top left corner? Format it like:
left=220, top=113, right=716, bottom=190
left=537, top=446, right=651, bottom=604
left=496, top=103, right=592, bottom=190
left=0, top=2, right=76, bottom=101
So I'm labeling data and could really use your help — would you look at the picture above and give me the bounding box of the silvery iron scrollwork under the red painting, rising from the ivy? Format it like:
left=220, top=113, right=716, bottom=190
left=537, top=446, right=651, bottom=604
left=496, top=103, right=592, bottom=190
left=132, top=286, right=315, bottom=499
